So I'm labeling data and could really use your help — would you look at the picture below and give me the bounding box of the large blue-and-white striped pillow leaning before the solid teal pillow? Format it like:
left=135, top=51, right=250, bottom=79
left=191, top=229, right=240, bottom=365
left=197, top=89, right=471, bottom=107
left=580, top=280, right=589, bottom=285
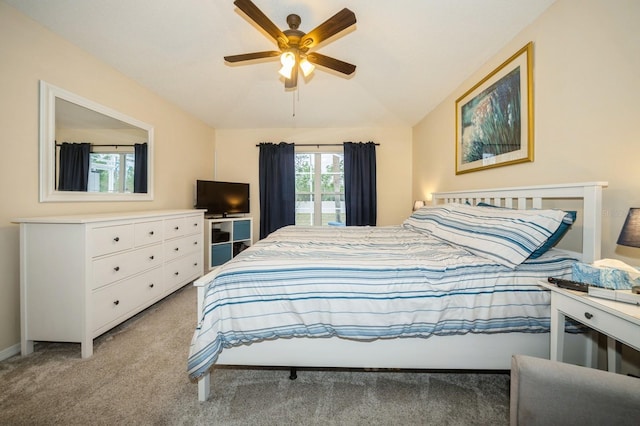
left=403, top=203, right=566, bottom=268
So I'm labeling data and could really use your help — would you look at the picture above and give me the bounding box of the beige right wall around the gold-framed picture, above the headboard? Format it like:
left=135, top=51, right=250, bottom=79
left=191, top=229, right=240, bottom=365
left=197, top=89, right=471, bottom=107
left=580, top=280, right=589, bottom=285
left=413, top=0, right=640, bottom=265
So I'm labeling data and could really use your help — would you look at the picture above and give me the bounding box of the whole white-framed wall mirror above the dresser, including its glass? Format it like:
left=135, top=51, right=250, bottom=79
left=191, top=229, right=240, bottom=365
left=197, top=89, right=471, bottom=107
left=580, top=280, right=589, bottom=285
left=40, top=81, right=153, bottom=202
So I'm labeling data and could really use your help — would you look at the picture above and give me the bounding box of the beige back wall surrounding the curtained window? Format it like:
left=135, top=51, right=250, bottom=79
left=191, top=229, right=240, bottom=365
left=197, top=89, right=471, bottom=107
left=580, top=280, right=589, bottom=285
left=215, top=128, right=413, bottom=243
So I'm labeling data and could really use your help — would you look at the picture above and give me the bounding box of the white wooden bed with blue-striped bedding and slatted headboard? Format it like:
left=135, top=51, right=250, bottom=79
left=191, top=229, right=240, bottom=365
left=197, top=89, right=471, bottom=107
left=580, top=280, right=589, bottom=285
left=188, top=182, right=607, bottom=401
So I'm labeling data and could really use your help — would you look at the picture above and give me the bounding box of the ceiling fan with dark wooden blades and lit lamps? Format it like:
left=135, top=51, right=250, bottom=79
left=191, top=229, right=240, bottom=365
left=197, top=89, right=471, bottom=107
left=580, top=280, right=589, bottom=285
left=224, top=0, right=356, bottom=89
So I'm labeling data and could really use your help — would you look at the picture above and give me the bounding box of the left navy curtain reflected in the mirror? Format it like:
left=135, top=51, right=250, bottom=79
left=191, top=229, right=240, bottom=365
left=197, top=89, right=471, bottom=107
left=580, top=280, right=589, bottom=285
left=58, top=142, right=91, bottom=191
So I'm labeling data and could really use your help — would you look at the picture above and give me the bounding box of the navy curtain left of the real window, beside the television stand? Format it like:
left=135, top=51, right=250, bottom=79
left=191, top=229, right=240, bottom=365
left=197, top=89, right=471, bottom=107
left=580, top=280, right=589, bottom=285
left=259, top=142, right=296, bottom=239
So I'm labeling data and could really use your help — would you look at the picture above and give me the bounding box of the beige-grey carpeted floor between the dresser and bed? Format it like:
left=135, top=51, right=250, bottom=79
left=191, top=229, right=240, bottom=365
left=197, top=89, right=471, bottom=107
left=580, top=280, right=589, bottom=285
left=0, top=286, right=509, bottom=425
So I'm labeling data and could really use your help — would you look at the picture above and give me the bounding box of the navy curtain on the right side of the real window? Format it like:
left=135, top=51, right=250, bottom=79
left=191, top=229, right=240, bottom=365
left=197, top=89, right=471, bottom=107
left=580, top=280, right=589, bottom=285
left=344, top=142, right=377, bottom=226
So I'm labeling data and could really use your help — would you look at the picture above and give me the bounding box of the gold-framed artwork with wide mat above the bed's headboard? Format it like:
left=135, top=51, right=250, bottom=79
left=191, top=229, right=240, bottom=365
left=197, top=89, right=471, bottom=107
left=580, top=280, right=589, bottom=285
left=456, top=43, right=533, bottom=174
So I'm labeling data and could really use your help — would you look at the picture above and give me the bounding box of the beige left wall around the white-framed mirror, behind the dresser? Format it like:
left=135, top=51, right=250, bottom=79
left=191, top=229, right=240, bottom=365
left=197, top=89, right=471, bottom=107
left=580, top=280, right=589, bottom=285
left=0, top=1, right=215, bottom=356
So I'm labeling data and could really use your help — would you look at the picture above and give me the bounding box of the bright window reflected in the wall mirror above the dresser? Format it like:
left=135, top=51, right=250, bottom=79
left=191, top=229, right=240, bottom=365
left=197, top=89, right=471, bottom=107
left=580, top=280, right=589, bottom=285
left=87, top=150, right=135, bottom=193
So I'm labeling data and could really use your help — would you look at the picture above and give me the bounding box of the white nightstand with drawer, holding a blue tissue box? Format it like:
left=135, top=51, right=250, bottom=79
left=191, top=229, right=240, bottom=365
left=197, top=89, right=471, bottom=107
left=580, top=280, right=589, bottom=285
left=540, top=282, right=640, bottom=371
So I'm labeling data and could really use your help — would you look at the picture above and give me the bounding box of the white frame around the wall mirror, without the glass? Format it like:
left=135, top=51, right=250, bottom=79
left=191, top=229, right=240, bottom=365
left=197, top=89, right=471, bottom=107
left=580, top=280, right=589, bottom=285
left=39, top=80, right=153, bottom=203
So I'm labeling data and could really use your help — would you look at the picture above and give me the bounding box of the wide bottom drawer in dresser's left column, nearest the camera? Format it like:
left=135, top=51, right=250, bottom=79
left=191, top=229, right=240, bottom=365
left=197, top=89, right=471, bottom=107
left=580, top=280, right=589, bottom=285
left=92, top=268, right=163, bottom=336
